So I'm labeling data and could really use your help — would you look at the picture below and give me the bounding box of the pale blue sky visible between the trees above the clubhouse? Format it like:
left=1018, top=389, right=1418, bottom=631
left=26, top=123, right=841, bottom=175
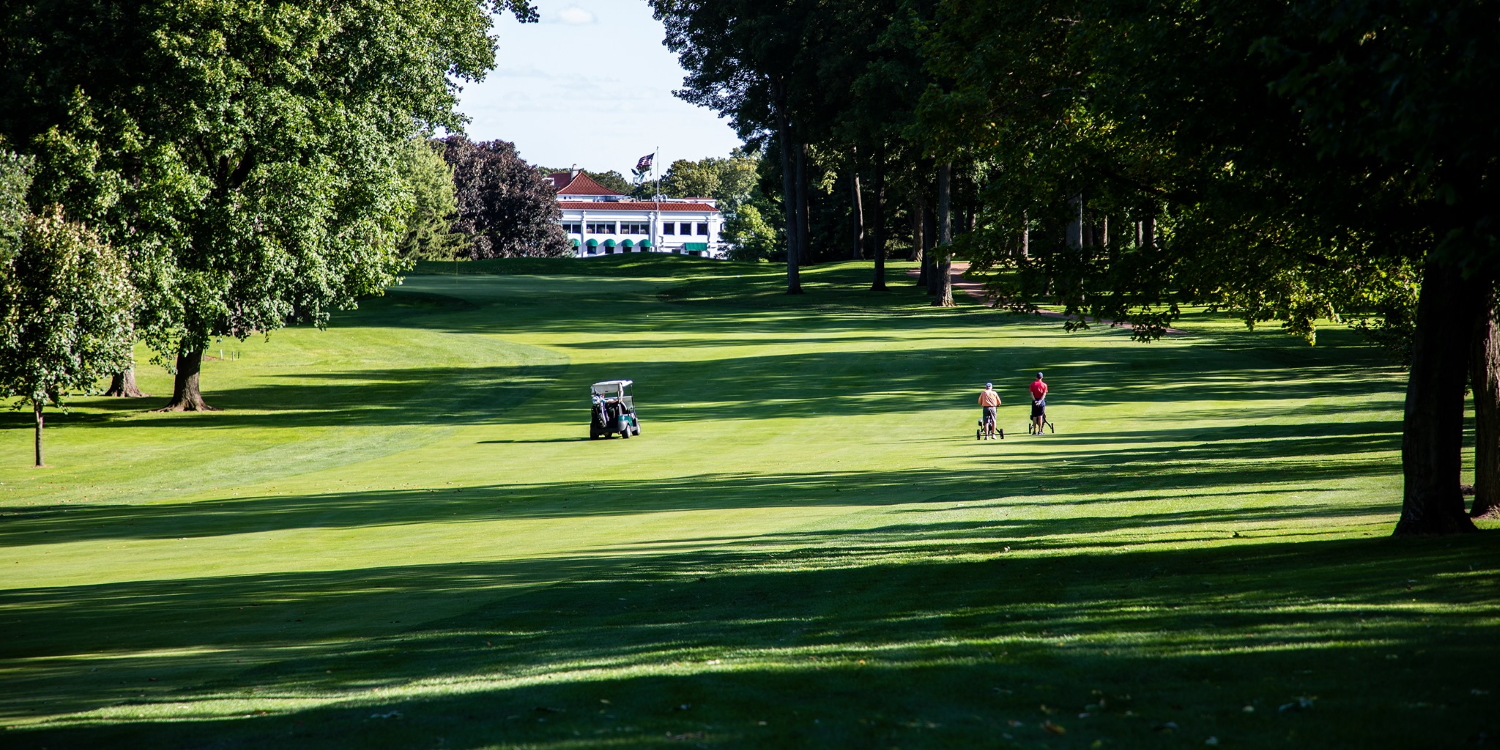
left=459, top=0, right=740, bottom=177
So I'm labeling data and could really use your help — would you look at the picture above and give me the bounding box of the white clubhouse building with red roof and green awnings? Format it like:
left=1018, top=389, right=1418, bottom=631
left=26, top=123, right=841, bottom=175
left=549, top=171, right=728, bottom=258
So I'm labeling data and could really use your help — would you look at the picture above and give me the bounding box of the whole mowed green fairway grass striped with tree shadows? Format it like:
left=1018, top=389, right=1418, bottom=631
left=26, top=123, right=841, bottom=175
left=0, top=258, right=1500, bottom=749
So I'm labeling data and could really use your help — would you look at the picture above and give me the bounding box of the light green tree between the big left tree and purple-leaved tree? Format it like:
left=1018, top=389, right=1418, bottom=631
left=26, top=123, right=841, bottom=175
left=396, top=140, right=468, bottom=261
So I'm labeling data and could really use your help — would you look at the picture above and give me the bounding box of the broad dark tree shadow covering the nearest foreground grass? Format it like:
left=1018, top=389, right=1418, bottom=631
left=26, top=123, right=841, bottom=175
left=0, top=534, right=1500, bottom=749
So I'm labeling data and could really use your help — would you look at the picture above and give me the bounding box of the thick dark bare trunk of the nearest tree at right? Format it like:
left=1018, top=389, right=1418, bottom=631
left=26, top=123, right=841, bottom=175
left=1395, top=258, right=1484, bottom=536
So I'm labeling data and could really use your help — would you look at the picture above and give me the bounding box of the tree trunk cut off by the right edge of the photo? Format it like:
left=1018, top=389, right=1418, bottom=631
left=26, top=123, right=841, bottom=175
left=1469, top=285, right=1500, bottom=518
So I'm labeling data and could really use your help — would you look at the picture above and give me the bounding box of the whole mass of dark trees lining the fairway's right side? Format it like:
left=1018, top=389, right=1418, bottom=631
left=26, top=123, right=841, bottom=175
left=651, top=0, right=1500, bottom=534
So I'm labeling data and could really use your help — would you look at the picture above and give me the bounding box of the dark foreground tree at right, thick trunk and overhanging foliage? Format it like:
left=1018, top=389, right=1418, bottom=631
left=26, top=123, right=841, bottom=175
left=926, top=0, right=1500, bottom=534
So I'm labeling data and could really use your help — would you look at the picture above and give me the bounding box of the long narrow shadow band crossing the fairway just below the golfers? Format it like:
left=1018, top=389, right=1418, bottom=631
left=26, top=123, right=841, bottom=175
left=0, top=423, right=1400, bottom=546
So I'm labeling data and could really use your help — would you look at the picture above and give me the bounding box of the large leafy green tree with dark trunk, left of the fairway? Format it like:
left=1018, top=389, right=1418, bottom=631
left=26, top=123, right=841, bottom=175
left=0, top=0, right=536, bottom=410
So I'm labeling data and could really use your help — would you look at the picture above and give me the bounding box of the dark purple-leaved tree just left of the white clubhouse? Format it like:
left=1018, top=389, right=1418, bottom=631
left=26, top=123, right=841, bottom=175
left=443, top=135, right=570, bottom=258
